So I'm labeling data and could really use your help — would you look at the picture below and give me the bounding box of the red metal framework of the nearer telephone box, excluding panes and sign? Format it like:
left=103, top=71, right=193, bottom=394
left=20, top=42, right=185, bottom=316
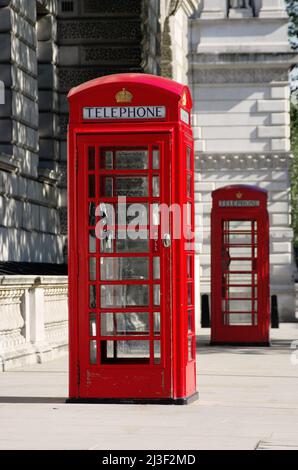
left=68, top=74, right=196, bottom=403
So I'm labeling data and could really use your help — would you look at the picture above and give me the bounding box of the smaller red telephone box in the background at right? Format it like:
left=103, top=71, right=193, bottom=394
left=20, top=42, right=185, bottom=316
left=211, top=185, right=270, bottom=346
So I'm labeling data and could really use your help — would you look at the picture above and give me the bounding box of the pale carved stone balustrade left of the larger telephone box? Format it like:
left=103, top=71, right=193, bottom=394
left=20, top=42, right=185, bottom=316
left=0, top=276, right=68, bottom=372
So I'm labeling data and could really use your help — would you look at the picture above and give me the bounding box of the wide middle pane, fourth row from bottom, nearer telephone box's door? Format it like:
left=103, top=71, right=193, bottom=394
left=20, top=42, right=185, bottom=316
left=100, top=257, right=149, bottom=281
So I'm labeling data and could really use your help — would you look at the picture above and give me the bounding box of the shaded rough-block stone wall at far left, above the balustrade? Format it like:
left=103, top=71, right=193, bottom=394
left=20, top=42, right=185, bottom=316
left=0, top=0, right=63, bottom=263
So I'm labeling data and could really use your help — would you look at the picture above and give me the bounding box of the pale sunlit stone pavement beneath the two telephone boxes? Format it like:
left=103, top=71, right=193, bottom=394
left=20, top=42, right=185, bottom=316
left=0, top=324, right=298, bottom=450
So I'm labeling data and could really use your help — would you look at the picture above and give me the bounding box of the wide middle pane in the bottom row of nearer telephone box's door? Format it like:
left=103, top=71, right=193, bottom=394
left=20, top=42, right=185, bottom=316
left=101, top=340, right=150, bottom=363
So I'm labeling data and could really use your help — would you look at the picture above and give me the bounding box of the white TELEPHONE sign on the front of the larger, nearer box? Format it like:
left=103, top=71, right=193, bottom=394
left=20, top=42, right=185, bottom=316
left=83, top=106, right=166, bottom=119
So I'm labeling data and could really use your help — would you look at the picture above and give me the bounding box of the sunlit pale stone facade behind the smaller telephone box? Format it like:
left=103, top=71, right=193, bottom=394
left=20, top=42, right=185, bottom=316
left=189, top=0, right=297, bottom=320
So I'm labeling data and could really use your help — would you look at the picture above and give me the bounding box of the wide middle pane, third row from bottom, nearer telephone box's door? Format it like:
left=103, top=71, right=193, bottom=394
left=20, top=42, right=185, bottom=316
left=100, top=284, right=149, bottom=308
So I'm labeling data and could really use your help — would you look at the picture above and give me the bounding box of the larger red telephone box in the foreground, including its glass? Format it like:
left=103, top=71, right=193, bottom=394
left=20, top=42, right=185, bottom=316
left=68, top=74, right=197, bottom=404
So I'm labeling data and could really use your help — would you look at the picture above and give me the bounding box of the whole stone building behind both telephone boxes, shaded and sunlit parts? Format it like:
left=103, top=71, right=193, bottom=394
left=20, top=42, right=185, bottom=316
left=0, top=0, right=296, bottom=370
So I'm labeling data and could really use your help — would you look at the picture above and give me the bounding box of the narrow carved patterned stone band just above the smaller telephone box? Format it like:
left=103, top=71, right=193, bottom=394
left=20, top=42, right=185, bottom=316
left=195, top=152, right=293, bottom=171
